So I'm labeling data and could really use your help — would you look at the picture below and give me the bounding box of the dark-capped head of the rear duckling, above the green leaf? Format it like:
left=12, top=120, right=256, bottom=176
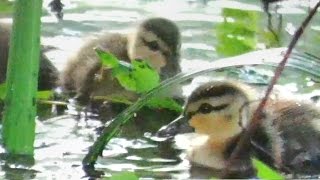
left=128, top=18, right=181, bottom=79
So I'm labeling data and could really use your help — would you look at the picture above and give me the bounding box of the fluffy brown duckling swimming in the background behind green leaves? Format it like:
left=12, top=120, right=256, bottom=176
left=61, top=18, right=181, bottom=104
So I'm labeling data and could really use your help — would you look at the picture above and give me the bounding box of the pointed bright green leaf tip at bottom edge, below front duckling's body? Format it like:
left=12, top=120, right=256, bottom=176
left=252, top=158, right=285, bottom=179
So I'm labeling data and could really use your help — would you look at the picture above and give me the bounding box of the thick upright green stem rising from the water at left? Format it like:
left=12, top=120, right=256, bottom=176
left=3, top=0, right=42, bottom=155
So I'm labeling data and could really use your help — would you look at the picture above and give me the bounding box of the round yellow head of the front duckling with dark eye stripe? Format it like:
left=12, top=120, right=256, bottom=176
left=185, top=81, right=254, bottom=140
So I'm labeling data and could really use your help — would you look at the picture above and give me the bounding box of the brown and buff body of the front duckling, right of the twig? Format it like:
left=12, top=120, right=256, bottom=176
left=252, top=101, right=320, bottom=175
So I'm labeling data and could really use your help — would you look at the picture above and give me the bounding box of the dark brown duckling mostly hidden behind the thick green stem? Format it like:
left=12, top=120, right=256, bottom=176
left=0, top=23, right=58, bottom=90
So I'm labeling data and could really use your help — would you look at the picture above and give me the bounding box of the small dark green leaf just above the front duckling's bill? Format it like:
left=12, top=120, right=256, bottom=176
left=147, top=97, right=183, bottom=112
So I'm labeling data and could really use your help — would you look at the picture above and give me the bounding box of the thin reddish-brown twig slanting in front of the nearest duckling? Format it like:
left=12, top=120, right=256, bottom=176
left=222, top=1, right=320, bottom=177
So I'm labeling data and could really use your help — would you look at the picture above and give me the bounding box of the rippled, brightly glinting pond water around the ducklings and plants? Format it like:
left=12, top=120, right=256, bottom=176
left=0, top=0, right=320, bottom=179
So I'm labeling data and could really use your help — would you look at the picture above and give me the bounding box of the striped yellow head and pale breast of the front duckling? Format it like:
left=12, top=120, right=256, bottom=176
left=184, top=81, right=254, bottom=177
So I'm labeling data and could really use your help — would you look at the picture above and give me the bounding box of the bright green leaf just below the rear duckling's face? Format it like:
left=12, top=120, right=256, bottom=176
left=132, top=60, right=160, bottom=93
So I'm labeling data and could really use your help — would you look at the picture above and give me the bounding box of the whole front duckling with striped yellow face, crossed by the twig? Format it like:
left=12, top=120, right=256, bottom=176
left=170, top=81, right=320, bottom=177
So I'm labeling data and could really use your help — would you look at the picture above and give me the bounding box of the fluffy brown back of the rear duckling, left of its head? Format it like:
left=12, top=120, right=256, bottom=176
left=60, top=34, right=130, bottom=97
